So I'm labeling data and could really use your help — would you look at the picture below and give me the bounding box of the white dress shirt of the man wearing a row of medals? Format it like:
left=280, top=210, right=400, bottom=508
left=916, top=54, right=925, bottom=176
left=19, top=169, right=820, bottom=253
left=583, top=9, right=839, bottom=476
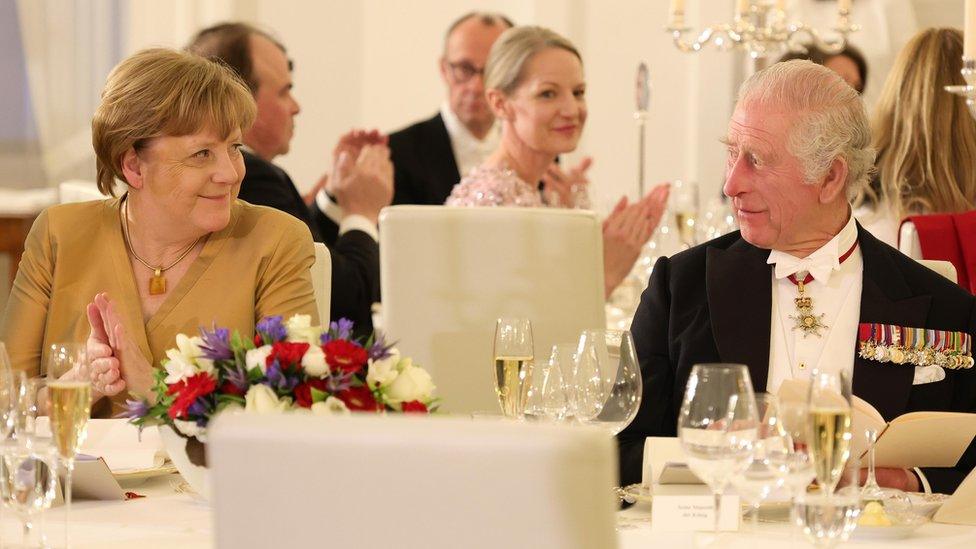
left=766, top=215, right=864, bottom=393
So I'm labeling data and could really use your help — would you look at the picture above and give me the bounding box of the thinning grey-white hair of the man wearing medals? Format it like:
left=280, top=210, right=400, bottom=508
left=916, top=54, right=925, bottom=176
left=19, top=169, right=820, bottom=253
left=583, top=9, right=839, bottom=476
left=737, top=59, right=876, bottom=196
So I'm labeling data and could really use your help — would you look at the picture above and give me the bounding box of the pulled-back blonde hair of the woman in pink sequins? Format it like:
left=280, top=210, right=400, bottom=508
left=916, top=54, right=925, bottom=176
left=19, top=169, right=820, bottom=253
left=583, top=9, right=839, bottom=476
left=485, top=26, right=583, bottom=95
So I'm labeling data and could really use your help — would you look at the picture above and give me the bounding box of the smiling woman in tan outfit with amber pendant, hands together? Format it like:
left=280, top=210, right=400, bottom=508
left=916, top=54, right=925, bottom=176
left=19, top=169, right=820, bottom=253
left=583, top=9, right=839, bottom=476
left=0, top=49, right=318, bottom=415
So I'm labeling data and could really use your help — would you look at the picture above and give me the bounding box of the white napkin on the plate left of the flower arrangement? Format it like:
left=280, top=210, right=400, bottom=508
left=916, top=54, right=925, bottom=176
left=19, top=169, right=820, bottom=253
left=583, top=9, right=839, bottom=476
left=37, top=417, right=166, bottom=473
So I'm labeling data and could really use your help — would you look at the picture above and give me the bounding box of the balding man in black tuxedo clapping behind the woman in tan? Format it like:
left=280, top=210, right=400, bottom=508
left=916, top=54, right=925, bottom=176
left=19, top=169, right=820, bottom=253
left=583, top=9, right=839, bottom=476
left=188, top=23, right=393, bottom=334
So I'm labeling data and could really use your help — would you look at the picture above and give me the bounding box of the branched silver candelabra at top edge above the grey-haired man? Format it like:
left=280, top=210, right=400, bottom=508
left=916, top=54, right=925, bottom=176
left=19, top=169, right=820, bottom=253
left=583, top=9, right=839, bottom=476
left=667, top=0, right=859, bottom=60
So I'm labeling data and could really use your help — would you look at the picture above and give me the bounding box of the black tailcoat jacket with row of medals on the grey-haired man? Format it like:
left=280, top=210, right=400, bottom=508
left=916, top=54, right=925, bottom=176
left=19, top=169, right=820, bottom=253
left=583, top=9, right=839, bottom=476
left=618, top=225, right=976, bottom=493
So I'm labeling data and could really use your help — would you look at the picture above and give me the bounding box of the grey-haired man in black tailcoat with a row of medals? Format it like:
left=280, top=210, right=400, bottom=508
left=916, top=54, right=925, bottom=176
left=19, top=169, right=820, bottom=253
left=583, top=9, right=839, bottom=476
left=618, top=61, right=976, bottom=493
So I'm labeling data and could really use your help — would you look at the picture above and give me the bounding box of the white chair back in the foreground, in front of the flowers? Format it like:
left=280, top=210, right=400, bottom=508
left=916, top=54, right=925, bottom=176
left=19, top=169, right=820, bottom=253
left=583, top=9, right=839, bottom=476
left=208, top=414, right=616, bottom=549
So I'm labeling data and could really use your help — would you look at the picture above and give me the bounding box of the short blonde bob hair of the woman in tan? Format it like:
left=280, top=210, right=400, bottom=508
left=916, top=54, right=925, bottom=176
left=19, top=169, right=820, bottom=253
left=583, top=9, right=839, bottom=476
left=92, top=48, right=257, bottom=196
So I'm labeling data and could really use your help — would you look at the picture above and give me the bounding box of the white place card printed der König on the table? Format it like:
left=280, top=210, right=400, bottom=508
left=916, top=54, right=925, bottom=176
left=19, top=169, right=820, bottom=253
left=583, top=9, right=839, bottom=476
left=651, top=490, right=739, bottom=532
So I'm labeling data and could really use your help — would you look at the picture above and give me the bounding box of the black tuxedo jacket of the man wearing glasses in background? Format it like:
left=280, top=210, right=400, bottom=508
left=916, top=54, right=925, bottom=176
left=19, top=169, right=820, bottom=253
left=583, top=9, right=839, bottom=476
left=390, top=113, right=461, bottom=206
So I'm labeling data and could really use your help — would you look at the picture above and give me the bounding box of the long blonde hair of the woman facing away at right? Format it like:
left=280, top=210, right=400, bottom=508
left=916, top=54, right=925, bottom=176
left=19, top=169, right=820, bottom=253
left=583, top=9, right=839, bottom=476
left=858, top=28, right=976, bottom=219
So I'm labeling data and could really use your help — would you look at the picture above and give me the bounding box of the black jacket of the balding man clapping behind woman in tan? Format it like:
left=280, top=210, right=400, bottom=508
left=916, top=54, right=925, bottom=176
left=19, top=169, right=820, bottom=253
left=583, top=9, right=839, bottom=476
left=238, top=151, right=380, bottom=335
